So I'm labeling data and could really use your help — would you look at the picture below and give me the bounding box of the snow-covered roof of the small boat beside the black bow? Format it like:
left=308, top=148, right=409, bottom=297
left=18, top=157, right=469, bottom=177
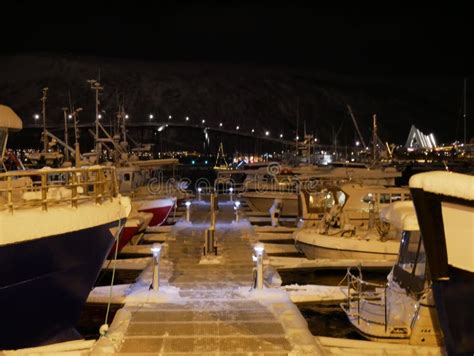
left=380, top=200, right=420, bottom=231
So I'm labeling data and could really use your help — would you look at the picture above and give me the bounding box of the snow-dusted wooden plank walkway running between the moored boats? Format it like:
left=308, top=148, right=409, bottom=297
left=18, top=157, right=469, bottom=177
left=92, top=202, right=322, bottom=355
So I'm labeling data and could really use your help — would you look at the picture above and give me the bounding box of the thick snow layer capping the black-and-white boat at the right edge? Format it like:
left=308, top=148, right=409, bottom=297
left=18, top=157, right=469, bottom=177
left=410, top=171, right=474, bottom=200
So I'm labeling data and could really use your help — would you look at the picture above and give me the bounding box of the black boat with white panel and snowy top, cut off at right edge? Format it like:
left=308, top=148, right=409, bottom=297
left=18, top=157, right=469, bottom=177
left=410, top=172, right=474, bottom=355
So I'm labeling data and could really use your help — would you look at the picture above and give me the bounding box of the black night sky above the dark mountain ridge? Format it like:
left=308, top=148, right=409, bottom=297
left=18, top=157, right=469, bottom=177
left=0, top=1, right=474, bottom=75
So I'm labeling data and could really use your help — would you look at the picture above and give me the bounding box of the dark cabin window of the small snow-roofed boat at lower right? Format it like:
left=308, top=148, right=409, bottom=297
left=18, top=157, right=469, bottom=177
left=393, top=231, right=426, bottom=293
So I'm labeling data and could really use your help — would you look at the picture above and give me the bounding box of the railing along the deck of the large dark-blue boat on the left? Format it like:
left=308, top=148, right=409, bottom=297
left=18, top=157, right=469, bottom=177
left=0, top=166, right=119, bottom=213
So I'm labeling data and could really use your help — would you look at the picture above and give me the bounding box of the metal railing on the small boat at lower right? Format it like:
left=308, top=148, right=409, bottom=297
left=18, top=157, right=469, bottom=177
left=346, top=267, right=389, bottom=332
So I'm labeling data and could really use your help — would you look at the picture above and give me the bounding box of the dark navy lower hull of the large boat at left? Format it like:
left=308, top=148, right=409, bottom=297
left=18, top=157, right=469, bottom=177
left=0, top=220, right=123, bottom=349
